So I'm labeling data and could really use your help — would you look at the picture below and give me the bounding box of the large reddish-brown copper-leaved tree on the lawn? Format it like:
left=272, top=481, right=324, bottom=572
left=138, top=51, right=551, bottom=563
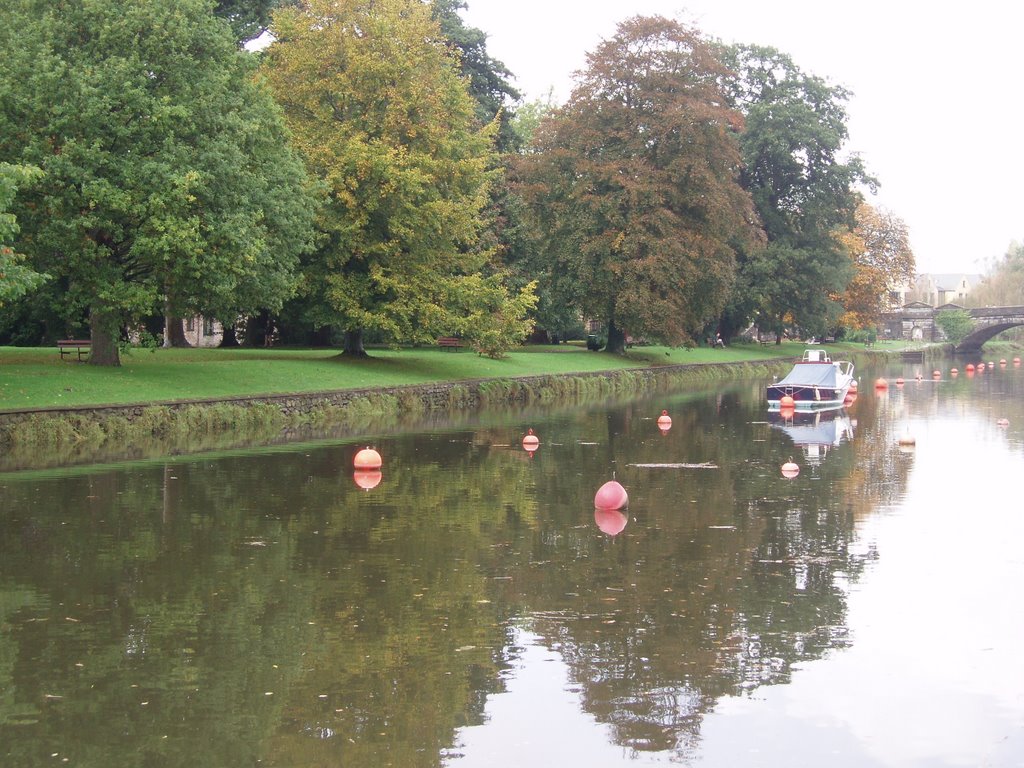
left=519, top=16, right=758, bottom=352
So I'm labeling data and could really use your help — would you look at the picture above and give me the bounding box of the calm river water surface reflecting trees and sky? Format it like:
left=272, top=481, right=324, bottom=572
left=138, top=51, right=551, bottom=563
left=0, top=361, right=1024, bottom=768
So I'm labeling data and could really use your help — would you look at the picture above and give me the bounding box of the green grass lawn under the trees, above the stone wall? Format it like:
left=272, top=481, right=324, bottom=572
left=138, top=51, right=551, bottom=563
left=0, top=342, right=889, bottom=411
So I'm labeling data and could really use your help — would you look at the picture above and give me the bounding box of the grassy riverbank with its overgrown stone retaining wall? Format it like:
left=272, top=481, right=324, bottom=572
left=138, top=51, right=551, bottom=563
left=0, top=343, right=937, bottom=471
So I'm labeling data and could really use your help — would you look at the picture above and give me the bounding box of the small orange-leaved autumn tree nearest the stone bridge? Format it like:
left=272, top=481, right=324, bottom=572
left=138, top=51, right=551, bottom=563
left=840, top=203, right=914, bottom=329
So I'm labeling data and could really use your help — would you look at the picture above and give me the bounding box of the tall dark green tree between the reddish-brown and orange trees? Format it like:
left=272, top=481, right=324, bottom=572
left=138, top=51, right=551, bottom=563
left=722, top=46, right=874, bottom=338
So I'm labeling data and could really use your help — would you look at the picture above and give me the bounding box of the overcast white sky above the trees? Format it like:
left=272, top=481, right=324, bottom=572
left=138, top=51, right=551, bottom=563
left=463, top=0, right=1024, bottom=272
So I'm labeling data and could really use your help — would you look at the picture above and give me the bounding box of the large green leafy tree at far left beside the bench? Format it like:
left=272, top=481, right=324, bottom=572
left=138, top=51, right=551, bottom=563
left=0, top=0, right=313, bottom=365
